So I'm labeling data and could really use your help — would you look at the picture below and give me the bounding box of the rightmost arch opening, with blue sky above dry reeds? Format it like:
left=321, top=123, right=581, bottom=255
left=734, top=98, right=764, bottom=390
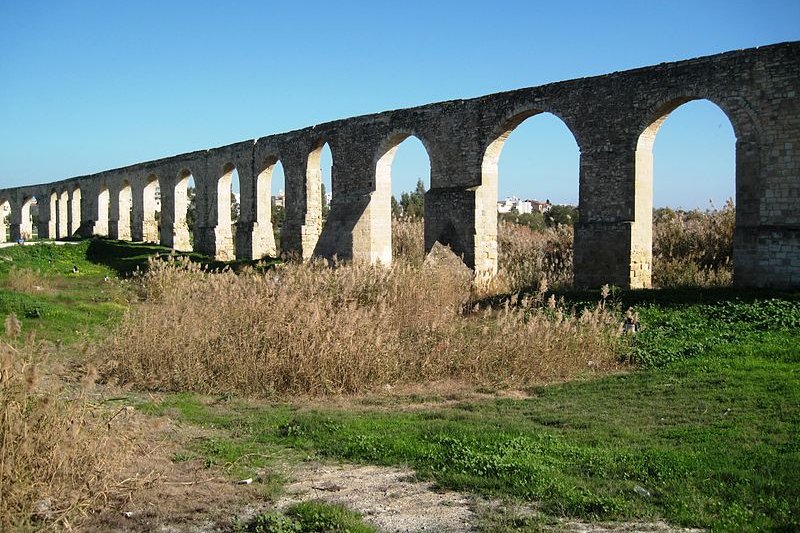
left=632, top=98, right=738, bottom=287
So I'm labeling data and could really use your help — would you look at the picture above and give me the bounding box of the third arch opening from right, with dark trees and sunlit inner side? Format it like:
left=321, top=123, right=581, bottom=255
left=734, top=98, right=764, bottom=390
left=372, top=133, right=431, bottom=265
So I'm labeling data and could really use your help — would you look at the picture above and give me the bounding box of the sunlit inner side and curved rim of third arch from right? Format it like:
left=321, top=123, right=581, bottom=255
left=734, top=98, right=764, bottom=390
left=369, top=130, right=431, bottom=265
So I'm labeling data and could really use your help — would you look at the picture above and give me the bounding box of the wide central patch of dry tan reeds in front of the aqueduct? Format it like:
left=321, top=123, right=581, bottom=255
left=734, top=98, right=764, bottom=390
left=102, top=258, right=620, bottom=397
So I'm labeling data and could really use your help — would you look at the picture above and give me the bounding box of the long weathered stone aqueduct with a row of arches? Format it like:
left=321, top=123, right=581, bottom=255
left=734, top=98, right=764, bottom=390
left=0, top=42, right=800, bottom=288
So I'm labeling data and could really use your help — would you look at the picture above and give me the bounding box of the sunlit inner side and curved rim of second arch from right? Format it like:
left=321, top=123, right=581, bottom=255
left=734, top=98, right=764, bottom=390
left=475, top=106, right=581, bottom=278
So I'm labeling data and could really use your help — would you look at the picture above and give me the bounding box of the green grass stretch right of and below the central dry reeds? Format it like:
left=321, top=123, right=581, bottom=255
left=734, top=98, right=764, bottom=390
left=141, top=292, right=800, bottom=531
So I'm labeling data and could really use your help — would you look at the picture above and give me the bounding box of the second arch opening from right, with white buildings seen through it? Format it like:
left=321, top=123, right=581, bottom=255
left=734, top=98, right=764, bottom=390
left=476, top=110, right=580, bottom=291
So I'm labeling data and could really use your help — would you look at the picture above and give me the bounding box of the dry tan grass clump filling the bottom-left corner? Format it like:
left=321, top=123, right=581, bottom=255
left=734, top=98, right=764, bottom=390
left=0, top=315, right=126, bottom=531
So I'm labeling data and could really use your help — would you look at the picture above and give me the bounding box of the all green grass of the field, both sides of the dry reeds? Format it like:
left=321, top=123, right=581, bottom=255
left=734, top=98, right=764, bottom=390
left=0, top=240, right=800, bottom=531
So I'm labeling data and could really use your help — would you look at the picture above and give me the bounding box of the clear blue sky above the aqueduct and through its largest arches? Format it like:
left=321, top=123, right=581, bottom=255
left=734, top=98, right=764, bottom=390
left=0, top=0, right=800, bottom=207
